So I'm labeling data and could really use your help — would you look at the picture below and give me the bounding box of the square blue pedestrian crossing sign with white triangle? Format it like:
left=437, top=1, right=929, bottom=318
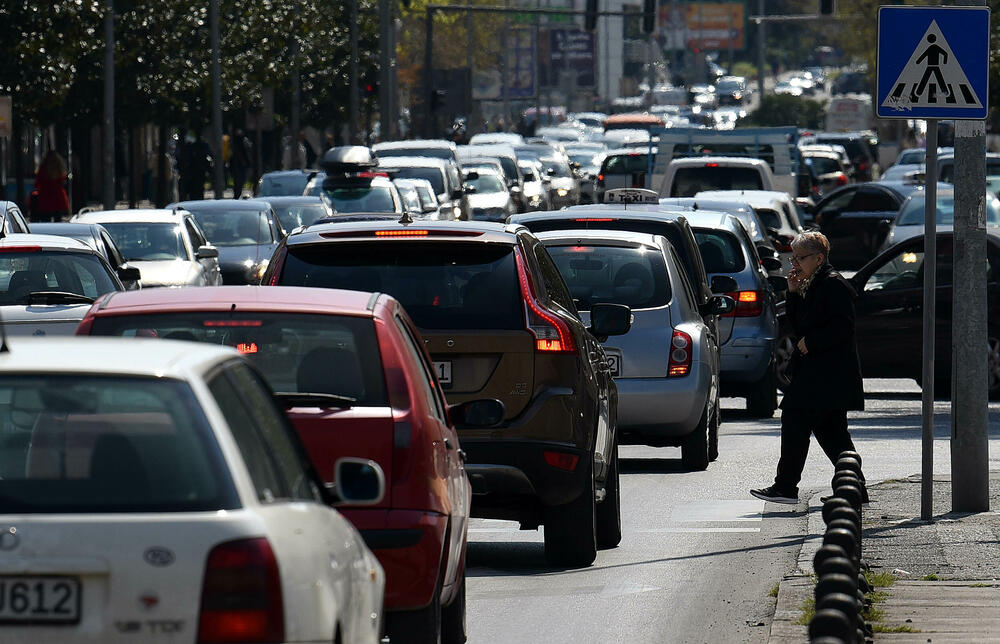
left=875, top=6, right=990, bottom=119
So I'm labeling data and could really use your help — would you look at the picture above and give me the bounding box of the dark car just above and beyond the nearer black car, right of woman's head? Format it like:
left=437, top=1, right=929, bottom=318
left=809, top=181, right=921, bottom=269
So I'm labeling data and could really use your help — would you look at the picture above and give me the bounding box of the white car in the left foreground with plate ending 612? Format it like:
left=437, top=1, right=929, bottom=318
left=0, top=338, right=385, bottom=644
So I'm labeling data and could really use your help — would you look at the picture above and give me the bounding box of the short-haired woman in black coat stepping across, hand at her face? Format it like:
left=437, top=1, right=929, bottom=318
left=750, top=232, right=867, bottom=504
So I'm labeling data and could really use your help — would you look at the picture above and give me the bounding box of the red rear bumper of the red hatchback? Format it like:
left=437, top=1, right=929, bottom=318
left=341, top=508, right=448, bottom=610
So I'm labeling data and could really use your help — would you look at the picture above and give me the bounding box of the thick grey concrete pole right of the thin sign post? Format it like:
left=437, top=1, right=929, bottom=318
left=951, top=0, right=990, bottom=512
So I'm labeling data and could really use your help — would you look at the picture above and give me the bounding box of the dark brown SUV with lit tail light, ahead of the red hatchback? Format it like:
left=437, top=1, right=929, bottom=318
left=263, top=218, right=631, bottom=566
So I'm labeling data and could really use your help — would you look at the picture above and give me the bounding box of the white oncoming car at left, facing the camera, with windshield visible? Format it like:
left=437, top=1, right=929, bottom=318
left=70, top=208, right=222, bottom=288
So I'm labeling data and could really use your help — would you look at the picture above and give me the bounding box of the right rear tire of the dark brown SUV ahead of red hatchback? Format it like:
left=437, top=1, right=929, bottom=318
left=545, top=457, right=597, bottom=568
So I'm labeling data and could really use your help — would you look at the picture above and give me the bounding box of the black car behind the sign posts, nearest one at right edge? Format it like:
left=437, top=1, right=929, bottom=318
left=851, top=230, right=1000, bottom=399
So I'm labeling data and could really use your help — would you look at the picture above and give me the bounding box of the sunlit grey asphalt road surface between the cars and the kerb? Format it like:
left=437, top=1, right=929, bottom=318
left=467, top=380, right=1000, bottom=644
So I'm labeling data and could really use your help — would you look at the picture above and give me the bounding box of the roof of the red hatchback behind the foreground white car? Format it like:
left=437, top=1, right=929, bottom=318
left=94, top=286, right=380, bottom=317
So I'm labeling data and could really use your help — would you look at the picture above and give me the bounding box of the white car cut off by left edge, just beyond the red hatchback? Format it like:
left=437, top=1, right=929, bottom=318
left=0, top=234, right=129, bottom=338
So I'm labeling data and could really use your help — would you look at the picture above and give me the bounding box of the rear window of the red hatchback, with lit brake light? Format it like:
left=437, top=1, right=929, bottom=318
left=91, top=311, right=388, bottom=407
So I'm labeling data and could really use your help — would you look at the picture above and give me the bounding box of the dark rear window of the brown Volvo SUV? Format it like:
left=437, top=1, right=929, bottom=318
left=280, top=241, right=524, bottom=330
